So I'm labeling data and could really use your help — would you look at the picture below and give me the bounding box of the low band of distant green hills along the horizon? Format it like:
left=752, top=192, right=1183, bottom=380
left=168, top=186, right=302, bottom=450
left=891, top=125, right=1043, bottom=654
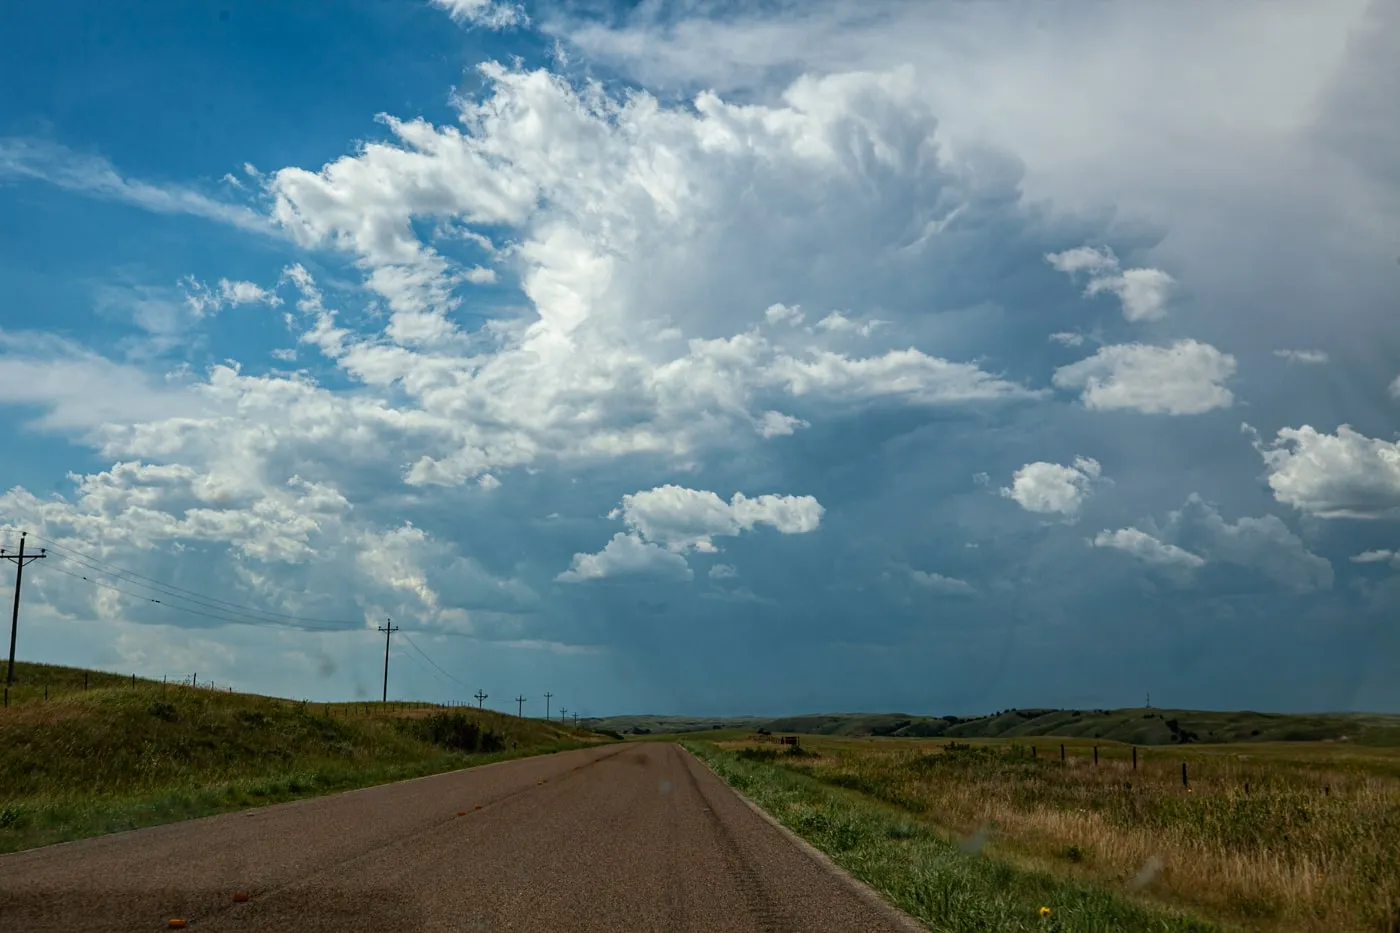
left=591, top=707, right=1400, bottom=745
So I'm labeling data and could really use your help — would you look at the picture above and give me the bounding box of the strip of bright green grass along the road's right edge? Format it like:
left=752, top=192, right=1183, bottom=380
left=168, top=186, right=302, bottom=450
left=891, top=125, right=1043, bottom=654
left=685, top=741, right=1217, bottom=933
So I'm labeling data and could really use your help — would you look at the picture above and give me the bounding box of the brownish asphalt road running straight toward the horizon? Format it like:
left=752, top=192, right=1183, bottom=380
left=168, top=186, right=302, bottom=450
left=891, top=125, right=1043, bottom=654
left=0, top=742, right=920, bottom=933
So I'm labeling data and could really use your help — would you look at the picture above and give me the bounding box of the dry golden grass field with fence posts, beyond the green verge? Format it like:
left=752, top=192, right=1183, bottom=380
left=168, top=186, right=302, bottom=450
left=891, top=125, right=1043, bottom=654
left=725, top=738, right=1400, bottom=933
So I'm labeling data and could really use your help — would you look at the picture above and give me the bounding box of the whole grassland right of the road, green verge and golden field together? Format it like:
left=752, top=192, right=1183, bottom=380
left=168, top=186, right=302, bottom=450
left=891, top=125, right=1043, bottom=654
left=686, top=737, right=1400, bottom=933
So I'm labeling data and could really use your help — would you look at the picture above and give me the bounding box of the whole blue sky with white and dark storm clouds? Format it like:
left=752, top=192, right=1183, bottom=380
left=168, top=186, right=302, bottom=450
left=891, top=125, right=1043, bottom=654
left=0, top=0, right=1400, bottom=716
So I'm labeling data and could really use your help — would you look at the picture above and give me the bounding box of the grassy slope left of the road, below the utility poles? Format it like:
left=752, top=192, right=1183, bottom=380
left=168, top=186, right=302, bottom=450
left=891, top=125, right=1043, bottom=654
left=0, top=664, right=608, bottom=852
